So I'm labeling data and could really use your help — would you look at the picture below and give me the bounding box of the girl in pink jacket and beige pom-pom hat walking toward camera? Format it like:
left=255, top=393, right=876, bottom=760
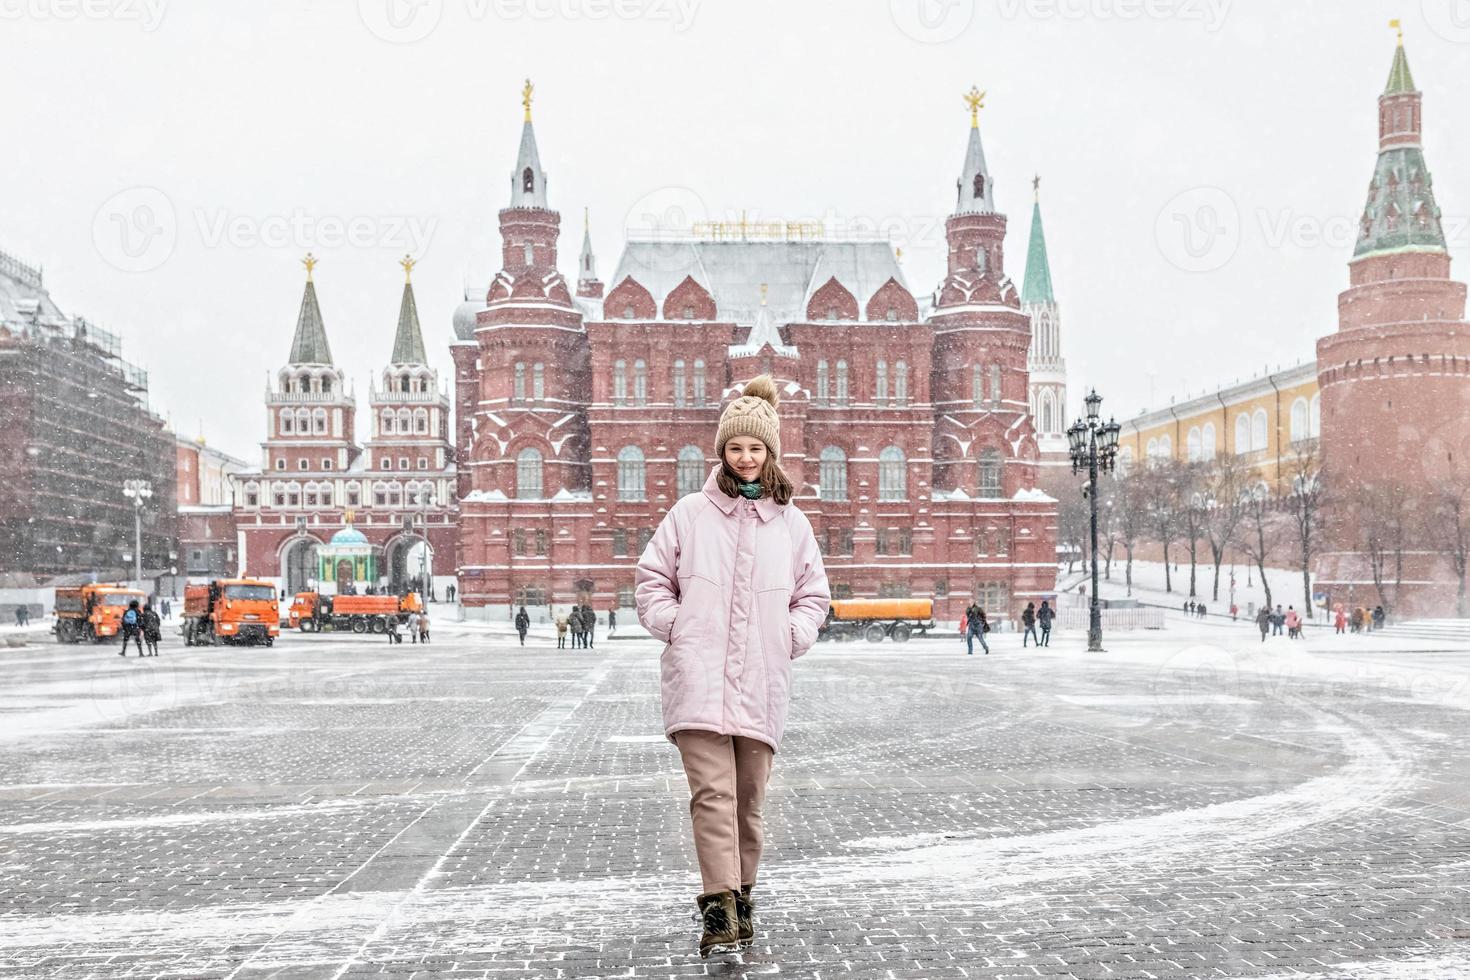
left=635, top=376, right=831, bottom=956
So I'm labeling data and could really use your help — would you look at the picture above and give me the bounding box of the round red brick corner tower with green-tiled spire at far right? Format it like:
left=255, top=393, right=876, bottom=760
left=1317, top=40, right=1470, bottom=616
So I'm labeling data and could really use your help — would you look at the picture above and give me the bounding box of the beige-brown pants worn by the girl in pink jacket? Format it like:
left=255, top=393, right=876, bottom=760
left=673, top=730, right=775, bottom=893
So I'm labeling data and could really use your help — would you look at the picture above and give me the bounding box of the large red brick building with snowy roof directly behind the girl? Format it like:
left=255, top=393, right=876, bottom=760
left=453, top=84, right=1060, bottom=619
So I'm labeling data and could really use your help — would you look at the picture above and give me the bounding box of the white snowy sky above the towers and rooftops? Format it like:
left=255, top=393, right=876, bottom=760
left=0, top=0, right=1470, bottom=460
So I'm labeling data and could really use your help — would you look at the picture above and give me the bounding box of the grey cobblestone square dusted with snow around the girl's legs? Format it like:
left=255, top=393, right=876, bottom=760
left=0, top=620, right=1470, bottom=980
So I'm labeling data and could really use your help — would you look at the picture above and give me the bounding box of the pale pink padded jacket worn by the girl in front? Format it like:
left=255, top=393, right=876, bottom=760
left=635, top=466, right=832, bottom=749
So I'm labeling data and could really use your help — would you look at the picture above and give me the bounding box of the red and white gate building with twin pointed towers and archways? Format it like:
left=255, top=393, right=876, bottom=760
left=232, top=256, right=457, bottom=592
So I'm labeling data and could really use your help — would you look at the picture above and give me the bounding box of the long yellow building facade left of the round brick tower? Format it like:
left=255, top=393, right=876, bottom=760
left=1119, top=361, right=1322, bottom=494
